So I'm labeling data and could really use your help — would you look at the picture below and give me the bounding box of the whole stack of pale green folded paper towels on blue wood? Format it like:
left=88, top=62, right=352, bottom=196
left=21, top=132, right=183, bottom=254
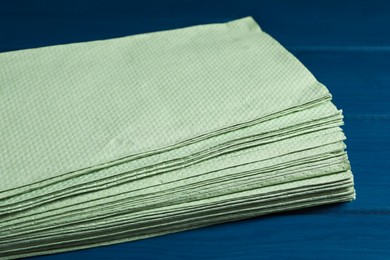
left=0, top=18, right=355, bottom=258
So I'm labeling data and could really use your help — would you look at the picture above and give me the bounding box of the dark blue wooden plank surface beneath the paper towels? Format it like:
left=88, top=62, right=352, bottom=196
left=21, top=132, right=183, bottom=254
left=0, top=0, right=390, bottom=260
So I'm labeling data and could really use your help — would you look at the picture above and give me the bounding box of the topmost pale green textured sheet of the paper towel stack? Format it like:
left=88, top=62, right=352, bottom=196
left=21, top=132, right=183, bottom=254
left=0, top=17, right=329, bottom=192
